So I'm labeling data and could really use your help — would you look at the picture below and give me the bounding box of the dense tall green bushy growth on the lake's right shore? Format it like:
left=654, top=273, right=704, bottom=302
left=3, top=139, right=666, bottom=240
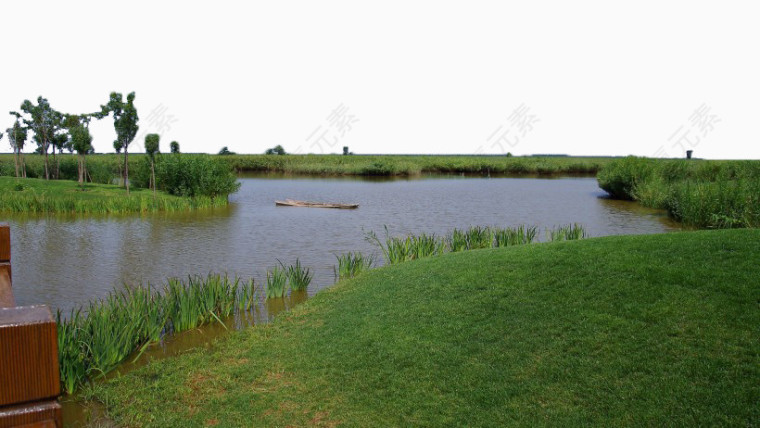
left=597, top=157, right=760, bottom=228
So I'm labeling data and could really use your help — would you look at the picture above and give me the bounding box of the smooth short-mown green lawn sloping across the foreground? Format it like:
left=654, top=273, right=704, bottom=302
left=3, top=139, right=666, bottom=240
left=88, top=230, right=760, bottom=426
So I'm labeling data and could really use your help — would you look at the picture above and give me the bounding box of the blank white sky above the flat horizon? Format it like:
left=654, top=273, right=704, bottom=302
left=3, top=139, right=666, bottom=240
left=0, top=0, right=760, bottom=159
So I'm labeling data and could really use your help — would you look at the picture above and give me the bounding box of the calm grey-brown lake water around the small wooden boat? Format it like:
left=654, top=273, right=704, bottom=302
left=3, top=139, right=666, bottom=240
left=0, top=176, right=679, bottom=312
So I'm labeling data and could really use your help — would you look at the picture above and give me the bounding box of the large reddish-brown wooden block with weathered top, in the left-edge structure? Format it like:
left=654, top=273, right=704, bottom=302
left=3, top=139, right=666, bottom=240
left=0, top=306, right=61, bottom=406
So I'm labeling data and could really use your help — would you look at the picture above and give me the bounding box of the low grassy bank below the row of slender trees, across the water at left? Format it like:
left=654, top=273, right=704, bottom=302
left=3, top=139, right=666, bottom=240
left=0, top=177, right=227, bottom=213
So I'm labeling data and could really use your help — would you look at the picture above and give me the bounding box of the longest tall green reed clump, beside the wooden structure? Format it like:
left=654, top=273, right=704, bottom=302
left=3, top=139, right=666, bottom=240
left=56, top=275, right=256, bottom=394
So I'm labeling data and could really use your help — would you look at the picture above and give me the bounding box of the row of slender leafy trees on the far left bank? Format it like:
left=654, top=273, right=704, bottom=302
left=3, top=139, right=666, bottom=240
left=0, top=92, right=179, bottom=193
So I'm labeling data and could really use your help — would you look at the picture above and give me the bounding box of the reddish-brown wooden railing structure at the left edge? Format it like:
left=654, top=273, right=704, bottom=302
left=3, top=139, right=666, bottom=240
left=0, top=224, right=63, bottom=428
